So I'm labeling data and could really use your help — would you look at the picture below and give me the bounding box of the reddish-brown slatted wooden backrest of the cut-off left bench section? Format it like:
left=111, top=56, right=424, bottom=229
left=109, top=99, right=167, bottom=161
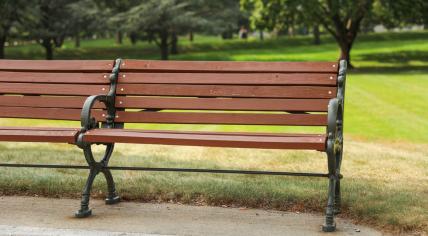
left=0, top=60, right=114, bottom=120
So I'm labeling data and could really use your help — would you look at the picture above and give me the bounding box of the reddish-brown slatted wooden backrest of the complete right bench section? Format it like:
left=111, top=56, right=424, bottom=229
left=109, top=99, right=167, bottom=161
left=112, top=60, right=339, bottom=126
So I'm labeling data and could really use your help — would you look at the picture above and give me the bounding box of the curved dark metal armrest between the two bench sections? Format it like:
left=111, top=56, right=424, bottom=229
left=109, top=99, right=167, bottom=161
left=80, top=95, right=114, bottom=132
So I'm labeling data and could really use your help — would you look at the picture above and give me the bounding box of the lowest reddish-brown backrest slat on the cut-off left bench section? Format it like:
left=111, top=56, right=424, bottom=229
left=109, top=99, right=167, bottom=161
left=0, top=107, right=105, bottom=121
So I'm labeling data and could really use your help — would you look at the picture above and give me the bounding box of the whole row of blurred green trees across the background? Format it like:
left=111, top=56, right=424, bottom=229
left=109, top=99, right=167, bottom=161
left=0, top=0, right=428, bottom=65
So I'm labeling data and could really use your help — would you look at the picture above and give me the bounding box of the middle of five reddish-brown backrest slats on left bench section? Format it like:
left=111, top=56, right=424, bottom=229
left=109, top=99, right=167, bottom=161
left=0, top=83, right=110, bottom=95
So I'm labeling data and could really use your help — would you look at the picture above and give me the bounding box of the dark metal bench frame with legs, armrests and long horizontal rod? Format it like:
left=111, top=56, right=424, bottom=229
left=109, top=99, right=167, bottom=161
left=0, top=59, right=347, bottom=232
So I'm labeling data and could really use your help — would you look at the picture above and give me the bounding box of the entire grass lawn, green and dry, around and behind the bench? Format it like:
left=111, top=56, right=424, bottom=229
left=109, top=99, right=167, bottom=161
left=0, top=32, right=428, bottom=232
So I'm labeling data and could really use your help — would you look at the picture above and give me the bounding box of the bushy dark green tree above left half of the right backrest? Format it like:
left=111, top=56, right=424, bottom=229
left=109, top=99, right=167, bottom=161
left=113, top=0, right=199, bottom=60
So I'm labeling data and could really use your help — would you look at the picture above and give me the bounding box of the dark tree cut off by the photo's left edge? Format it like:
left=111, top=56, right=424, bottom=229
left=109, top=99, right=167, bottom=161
left=0, top=0, right=26, bottom=59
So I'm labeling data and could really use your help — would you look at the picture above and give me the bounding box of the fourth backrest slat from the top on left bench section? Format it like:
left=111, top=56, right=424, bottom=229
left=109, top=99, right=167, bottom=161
left=0, top=96, right=105, bottom=109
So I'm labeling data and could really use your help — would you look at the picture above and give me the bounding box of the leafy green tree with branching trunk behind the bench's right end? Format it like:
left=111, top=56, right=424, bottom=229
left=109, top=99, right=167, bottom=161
left=241, top=0, right=372, bottom=67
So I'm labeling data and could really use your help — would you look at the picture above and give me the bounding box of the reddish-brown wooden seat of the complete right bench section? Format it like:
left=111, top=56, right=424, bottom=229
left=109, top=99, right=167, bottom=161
left=83, top=129, right=326, bottom=150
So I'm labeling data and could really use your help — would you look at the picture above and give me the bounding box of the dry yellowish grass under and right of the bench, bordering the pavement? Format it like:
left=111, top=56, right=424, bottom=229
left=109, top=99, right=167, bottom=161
left=0, top=141, right=428, bottom=232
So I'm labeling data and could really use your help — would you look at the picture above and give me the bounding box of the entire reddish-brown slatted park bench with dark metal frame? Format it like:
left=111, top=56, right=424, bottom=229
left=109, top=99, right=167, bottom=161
left=0, top=59, right=346, bottom=231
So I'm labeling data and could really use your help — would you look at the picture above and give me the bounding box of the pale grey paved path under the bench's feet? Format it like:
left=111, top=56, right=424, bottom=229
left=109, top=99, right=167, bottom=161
left=0, top=197, right=381, bottom=236
